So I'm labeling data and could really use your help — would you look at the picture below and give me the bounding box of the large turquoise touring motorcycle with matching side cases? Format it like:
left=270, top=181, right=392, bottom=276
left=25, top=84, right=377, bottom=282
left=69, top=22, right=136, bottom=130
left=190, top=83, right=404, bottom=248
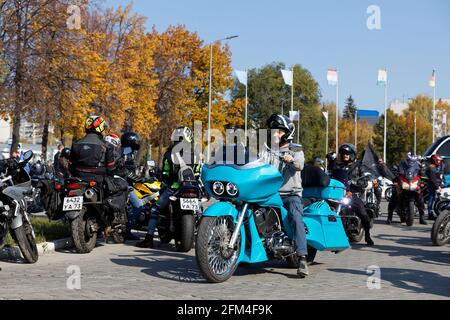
left=195, top=145, right=350, bottom=283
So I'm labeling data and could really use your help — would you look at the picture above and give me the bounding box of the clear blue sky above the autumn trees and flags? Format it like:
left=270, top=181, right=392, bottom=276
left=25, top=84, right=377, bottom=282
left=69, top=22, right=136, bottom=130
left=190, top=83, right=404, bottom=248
left=104, top=0, right=450, bottom=110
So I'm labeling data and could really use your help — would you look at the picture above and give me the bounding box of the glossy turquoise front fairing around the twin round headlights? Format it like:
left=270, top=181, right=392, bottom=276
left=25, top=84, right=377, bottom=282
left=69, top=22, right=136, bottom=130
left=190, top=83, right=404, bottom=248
left=202, top=161, right=283, bottom=202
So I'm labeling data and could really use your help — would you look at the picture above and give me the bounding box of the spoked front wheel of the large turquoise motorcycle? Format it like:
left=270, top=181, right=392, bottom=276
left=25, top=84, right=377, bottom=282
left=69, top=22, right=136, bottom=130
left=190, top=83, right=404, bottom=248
left=195, top=216, right=241, bottom=283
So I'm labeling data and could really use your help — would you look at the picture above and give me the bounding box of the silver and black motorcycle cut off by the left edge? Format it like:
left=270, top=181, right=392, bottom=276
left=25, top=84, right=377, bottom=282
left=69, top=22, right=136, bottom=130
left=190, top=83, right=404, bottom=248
left=0, top=151, right=39, bottom=263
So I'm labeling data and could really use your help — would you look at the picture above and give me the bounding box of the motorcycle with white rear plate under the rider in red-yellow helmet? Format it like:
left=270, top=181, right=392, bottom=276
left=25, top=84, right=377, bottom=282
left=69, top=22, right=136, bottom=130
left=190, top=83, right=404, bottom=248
left=62, top=176, right=128, bottom=253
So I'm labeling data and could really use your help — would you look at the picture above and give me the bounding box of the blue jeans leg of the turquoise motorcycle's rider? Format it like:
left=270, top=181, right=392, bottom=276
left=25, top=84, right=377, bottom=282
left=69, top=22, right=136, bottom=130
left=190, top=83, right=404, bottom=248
left=282, top=195, right=308, bottom=256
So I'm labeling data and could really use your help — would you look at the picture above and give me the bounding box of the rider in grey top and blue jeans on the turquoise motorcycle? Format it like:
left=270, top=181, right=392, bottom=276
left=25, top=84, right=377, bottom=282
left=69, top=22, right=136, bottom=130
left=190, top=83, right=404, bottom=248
left=261, top=114, right=309, bottom=278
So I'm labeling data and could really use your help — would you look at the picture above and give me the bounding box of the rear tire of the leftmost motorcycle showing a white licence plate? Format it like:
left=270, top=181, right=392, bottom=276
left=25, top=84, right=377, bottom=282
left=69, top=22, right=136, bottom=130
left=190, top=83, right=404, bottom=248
left=71, top=207, right=97, bottom=253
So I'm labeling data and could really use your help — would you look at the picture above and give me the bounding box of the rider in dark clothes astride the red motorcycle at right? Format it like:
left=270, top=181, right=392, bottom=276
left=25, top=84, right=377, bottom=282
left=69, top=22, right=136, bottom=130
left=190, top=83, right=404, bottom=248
left=386, top=152, right=427, bottom=225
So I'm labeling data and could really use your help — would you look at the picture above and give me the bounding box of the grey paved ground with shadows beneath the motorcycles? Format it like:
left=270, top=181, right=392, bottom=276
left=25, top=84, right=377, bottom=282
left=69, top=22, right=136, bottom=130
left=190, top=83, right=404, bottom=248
left=0, top=204, right=450, bottom=300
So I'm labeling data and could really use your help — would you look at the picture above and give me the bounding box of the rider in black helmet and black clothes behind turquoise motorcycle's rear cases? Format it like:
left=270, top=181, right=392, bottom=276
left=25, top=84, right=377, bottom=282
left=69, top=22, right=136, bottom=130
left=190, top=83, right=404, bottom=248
left=328, top=143, right=374, bottom=246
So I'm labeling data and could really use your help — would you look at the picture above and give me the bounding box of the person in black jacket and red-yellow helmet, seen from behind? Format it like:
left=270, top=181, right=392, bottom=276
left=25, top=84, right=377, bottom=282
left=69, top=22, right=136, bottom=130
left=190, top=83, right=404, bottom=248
left=70, top=116, right=116, bottom=186
